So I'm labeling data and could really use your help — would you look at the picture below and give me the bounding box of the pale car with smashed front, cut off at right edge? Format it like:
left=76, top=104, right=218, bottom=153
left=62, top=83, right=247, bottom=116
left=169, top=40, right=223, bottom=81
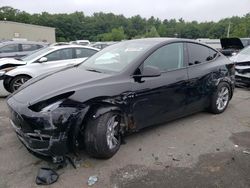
left=230, top=46, right=250, bottom=87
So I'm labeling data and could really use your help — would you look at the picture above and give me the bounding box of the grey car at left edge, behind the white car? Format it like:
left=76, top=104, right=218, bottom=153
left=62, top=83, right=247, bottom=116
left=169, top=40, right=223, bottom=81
left=0, top=41, right=48, bottom=58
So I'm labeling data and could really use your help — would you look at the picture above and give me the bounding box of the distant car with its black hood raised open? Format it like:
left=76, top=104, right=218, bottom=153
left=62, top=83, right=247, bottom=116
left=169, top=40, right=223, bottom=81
left=220, top=38, right=250, bottom=56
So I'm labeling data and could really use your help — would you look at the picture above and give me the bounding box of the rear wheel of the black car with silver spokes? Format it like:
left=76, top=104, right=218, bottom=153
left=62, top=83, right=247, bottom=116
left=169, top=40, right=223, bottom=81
left=210, top=82, right=231, bottom=114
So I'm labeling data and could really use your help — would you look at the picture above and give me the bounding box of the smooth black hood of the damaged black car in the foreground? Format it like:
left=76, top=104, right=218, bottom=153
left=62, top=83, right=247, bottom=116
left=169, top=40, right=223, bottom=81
left=10, top=67, right=111, bottom=105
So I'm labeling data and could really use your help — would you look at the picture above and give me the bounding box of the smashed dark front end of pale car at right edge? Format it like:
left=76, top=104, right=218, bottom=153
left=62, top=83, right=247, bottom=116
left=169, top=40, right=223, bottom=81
left=235, top=61, right=250, bottom=87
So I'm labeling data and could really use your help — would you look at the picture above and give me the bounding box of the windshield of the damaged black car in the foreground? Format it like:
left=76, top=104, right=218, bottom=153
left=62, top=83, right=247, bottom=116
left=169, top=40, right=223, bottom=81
left=80, top=40, right=156, bottom=72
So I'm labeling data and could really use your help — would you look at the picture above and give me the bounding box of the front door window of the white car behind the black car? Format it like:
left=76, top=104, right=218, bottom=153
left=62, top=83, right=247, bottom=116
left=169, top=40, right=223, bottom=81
left=45, top=48, right=73, bottom=61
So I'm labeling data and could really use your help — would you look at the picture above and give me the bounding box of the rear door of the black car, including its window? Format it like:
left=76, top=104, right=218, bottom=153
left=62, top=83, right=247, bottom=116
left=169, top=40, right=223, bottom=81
left=186, top=43, right=219, bottom=113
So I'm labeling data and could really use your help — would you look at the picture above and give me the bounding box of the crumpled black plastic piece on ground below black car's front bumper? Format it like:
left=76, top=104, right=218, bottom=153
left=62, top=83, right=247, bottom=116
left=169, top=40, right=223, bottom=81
left=36, top=167, right=59, bottom=185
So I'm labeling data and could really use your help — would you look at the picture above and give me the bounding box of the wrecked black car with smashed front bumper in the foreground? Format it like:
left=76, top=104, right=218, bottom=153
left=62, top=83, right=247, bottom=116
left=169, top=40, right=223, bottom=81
left=7, top=38, right=234, bottom=161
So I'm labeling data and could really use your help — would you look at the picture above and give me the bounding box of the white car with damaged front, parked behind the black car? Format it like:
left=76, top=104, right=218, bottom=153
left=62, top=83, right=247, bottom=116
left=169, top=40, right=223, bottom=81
left=0, top=45, right=99, bottom=96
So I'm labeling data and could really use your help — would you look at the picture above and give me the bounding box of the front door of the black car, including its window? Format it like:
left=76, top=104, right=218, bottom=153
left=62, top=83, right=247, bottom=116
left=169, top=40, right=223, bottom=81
left=132, top=43, right=188, bottom=129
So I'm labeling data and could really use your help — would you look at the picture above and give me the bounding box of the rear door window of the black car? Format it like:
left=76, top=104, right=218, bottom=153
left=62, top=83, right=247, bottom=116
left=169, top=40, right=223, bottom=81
left=187, top=43, right=217, bottom=65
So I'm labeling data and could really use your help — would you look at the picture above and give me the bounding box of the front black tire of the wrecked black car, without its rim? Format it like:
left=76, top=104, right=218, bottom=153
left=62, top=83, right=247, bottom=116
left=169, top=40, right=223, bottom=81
left=84, top=112, right=121, bottom=159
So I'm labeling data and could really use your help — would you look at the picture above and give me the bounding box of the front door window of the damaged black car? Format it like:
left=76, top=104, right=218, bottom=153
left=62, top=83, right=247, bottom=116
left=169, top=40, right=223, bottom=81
left=144, top=43, right=184, bottom=72
